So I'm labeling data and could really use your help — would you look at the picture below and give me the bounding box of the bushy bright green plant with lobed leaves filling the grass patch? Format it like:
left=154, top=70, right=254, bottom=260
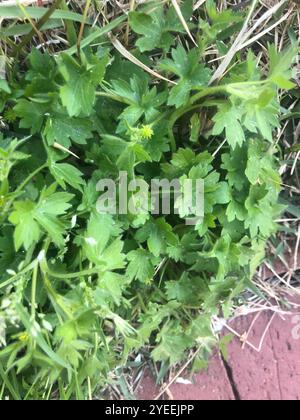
left=0, top=1, right=298, bottom=399
